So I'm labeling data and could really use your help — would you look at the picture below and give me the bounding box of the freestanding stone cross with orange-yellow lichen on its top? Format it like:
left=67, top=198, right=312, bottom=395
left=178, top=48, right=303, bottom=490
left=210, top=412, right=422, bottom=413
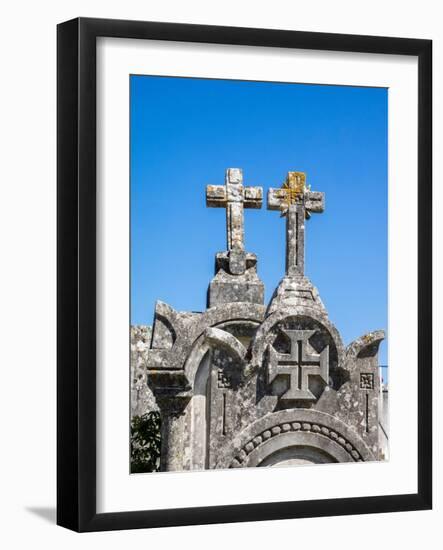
left=268, top=172, right=325, bottom=276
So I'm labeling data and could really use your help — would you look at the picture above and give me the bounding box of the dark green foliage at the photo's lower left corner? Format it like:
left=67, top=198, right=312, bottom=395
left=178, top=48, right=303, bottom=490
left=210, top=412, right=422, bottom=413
left=131, top=411, right=160, bottom=474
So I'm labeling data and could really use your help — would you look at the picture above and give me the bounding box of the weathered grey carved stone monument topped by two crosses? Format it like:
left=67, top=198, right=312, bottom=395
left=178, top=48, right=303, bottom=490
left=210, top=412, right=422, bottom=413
left=139, top=168, right=384, bottom=471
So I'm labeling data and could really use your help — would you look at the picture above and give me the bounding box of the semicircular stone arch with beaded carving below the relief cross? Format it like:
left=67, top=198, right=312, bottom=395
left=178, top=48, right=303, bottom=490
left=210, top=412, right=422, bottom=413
left=216, top=409, right=375, bottom=468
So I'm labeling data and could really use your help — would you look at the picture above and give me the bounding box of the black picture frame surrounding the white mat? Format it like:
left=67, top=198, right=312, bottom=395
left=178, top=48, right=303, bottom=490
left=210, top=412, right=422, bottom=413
left=57, top=18, right=432, bottom=531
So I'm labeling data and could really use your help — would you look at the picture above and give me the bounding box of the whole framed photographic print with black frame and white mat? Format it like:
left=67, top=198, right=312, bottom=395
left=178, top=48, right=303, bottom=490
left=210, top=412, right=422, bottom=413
left=57, top=18, right=432, bottom=531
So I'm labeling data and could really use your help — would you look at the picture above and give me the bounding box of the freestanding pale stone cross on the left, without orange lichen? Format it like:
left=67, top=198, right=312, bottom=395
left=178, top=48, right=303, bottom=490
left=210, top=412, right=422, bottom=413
left=206, top=168, right=263, bottom=275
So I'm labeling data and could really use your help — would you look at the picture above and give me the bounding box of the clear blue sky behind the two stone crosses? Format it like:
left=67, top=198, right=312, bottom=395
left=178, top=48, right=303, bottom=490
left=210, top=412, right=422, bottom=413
left=130, top=75, right=388, bottom=364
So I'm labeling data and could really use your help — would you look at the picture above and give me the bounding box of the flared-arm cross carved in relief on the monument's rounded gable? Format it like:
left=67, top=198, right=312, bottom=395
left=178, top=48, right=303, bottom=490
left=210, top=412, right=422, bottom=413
left=268, top=329, right=329, bottom=401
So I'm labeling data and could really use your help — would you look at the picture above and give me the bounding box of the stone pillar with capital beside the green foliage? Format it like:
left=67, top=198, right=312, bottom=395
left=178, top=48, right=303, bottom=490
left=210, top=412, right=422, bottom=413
left=157, top=395, right=190, bottom=472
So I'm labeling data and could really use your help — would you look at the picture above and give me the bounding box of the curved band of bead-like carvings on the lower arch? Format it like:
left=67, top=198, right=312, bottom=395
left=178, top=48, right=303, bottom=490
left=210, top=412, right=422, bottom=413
left=229, top=422, right=363, bottom=468
